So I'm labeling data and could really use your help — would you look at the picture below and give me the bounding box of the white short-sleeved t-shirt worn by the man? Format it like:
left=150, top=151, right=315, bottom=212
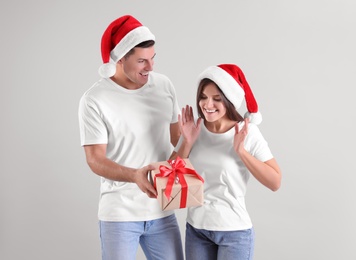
left=79, top=72, right=179, bottom=221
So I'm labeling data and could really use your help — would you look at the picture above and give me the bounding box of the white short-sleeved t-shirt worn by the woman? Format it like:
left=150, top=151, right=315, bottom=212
left=175, top=122, right=273, bottom=231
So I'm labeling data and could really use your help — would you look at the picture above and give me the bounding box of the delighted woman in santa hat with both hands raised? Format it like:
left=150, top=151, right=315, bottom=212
left=172, top=64, right=281, bottom=260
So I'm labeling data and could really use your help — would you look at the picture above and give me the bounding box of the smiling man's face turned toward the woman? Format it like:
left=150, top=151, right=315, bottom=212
left=120, top=46, right=156, bottom=89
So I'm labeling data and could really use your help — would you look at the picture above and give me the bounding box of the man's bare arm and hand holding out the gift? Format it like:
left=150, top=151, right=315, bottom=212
left=84, top=144, right=157, bottom=198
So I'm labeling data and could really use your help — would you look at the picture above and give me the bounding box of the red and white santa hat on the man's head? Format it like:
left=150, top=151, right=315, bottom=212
left=99, top=15, right=155, bottom=78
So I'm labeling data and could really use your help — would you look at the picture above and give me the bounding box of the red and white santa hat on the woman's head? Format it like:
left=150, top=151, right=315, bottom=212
left=198, top=64, right=262, bottom=125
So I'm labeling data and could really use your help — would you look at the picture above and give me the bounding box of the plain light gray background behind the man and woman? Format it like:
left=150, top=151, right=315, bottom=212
left=0, top=0, right=356, bottom=260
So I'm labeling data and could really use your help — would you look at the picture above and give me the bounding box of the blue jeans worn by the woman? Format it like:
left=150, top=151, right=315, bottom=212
left=185, top=223, right=255, bottom=260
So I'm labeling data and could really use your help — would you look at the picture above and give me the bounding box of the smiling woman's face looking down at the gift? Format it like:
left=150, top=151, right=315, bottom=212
left=199, top=83, right=226, bottom=122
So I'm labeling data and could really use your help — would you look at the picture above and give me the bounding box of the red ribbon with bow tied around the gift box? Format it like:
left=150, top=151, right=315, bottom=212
left=155, top=156, right=204, bottom=208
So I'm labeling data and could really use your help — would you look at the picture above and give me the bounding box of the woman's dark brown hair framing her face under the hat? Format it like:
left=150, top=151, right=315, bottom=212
left=196, top=78, right=244, bottom=122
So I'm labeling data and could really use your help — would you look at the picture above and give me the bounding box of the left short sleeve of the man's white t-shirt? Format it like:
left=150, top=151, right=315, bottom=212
left=78, top=95, right=108, bottom=146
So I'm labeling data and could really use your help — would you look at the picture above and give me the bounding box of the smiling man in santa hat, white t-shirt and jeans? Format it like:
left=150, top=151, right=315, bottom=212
left=79, top=15, right=183, bottom=260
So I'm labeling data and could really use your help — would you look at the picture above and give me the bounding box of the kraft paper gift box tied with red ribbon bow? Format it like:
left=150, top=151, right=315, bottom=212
left=149, top=157, right=204, bottom=210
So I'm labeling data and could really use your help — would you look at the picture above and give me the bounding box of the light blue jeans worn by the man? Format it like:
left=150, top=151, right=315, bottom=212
left=99, top=214, right=184, bottom=260
